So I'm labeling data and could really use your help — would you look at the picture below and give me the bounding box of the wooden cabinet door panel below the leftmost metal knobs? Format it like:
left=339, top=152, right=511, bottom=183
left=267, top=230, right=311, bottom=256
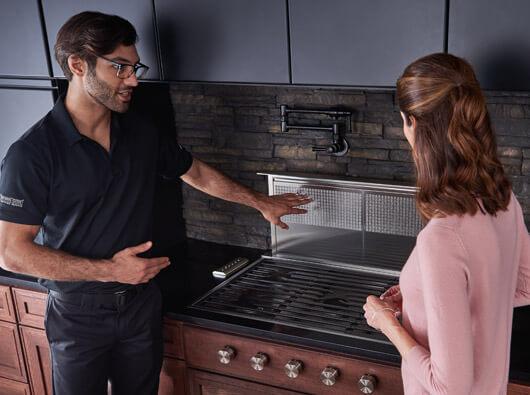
left=188, top=369, right=301, bottom=395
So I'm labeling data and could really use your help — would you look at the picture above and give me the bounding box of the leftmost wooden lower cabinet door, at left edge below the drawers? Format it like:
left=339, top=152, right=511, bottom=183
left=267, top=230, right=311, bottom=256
left=0, top=321, right=27, bottom=382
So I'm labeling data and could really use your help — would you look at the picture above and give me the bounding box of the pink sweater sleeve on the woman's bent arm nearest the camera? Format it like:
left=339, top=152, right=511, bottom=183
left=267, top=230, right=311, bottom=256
left=406, top=225, right=473, bottom=395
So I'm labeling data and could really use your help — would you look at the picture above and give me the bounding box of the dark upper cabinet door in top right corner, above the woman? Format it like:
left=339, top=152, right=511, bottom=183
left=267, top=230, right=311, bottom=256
left=448, top=0, right=530, bottom=91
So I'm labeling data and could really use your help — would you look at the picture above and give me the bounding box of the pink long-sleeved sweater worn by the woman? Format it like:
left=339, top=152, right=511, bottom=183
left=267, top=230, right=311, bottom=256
left=399, top=194, right=530, bottom=395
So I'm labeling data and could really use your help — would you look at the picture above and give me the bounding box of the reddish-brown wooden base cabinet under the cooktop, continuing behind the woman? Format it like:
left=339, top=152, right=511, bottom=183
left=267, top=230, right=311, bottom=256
left=178, top=324, right=530, bottom=395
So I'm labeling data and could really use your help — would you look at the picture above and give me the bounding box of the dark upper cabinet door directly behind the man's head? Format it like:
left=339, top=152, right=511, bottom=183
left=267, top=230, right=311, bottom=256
left=42, top=0, right=160, bottom=80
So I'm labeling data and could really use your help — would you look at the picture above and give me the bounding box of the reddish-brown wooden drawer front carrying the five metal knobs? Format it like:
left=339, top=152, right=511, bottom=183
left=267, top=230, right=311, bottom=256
left=182, top=325, right=403, bottom=395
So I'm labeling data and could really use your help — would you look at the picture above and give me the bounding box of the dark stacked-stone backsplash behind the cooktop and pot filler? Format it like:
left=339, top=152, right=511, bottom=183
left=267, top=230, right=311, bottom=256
left=171, top=84, right=530, bottom=249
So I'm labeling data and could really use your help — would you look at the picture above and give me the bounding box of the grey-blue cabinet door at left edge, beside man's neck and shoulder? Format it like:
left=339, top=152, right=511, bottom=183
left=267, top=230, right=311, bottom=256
left=0, top=89, right=53, bottom=160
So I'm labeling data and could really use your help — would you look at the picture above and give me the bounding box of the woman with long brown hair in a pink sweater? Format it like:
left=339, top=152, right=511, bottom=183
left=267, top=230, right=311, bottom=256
left=364, top=53, right=530, bottom=395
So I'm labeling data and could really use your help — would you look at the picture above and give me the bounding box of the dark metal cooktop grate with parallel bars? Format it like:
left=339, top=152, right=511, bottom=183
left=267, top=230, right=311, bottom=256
left=192, top=258, right=398, bottom=344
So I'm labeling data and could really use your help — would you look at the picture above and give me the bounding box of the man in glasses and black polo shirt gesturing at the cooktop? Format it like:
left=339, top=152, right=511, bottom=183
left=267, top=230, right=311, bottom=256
left=0, top=12, right=309, bottom=395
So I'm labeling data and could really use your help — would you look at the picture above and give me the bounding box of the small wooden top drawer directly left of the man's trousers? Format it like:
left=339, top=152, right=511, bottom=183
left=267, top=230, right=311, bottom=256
left=13, top=288, right=47, bottom=329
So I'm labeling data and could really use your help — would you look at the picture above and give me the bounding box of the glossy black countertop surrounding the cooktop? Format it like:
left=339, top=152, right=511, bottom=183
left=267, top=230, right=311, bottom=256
left=0, top=239, right=530, bottom=382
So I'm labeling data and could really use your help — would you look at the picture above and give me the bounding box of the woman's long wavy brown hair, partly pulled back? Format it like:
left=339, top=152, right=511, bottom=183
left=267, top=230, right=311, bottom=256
left=397, top=53, right=511, bottom=220
